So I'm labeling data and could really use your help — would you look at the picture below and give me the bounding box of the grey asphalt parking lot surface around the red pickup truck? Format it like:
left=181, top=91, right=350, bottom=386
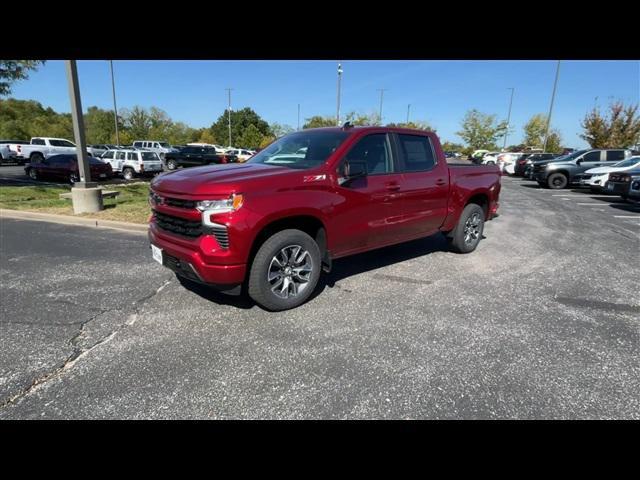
left=0, top=178, right=640, bottom=419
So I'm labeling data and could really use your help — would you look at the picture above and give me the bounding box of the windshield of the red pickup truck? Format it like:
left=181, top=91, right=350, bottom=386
left=247, top=130, right=349, bottom=169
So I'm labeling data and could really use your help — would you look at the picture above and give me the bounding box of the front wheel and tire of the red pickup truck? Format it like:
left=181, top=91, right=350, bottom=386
left=248, top=229, right=322, bottom=311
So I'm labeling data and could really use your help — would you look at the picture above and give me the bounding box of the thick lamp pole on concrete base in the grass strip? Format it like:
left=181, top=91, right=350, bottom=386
left=65, top=60, right=103, bottom=213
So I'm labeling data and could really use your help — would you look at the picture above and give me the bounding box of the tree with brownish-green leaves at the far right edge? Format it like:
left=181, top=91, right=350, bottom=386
left=580, top=101, right=640, bottom=148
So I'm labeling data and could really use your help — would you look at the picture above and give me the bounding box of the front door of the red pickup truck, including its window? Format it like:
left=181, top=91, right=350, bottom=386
left=332, top=129, right=402, bottom=256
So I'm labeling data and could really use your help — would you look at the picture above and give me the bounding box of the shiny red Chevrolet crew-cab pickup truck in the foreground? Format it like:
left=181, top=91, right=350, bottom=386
left=149, top=124, right=500, bottom=311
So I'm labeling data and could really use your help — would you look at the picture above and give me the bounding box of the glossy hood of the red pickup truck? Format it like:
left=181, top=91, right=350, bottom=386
left=151, top=163, right=292, bottom=195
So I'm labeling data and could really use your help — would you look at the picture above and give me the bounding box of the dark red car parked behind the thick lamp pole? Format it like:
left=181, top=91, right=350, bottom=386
left=24, top=155, right=113, bottom=183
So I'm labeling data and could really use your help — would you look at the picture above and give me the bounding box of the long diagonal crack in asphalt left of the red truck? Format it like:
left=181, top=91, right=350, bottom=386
left=0, top=280, right=173, bottom=411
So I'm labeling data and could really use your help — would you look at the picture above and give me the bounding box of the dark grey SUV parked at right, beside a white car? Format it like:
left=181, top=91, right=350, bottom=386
left=533, top=148, right=631, bottom=189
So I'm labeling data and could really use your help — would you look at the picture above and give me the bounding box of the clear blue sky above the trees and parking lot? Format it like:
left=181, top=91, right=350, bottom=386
left=7, top=60, right=640, bottom=147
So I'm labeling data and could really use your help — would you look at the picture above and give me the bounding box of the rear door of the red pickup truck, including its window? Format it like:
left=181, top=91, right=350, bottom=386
left=394, top=133, right=449, bottom=238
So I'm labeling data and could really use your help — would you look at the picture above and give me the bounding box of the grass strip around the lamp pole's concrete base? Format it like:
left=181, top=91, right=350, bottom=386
left=0, top=183, right=151, bottom=223
